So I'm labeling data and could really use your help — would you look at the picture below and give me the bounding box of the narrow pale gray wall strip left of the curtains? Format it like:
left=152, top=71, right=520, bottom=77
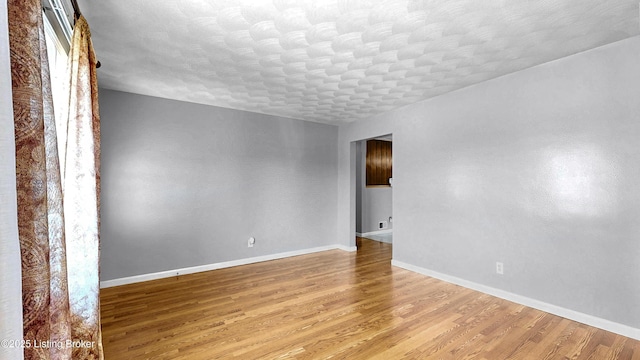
left=0, top=1, right=23, bottom=359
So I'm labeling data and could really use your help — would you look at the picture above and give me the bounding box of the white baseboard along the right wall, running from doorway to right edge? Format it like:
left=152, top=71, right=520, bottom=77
left=391, top=260, right=640, bottom=340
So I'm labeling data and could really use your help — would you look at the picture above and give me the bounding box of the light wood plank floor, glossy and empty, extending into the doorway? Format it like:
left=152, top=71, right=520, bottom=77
left=101, top=239, right=640, bottom=360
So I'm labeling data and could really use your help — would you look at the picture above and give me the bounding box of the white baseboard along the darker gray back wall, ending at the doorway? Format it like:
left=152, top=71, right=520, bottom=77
left=100, top=244, right=358, bottom=289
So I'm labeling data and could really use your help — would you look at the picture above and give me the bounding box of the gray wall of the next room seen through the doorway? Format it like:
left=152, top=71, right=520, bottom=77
left=356, top=140, right=393, bottom=234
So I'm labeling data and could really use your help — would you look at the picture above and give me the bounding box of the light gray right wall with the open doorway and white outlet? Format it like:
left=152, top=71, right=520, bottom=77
left=338, top=37, right=640, bottom=328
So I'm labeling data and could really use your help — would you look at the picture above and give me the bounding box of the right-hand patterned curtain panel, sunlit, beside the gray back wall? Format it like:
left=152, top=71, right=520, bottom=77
left=63, top=16, right=102, bottom=359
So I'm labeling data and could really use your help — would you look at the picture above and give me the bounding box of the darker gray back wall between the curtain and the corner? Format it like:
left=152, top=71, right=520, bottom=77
left=100, top=89, right=338, bottom=280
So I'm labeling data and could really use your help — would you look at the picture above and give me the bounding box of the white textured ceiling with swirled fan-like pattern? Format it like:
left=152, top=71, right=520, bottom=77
left=79, top=0, right=640, bottom=124
